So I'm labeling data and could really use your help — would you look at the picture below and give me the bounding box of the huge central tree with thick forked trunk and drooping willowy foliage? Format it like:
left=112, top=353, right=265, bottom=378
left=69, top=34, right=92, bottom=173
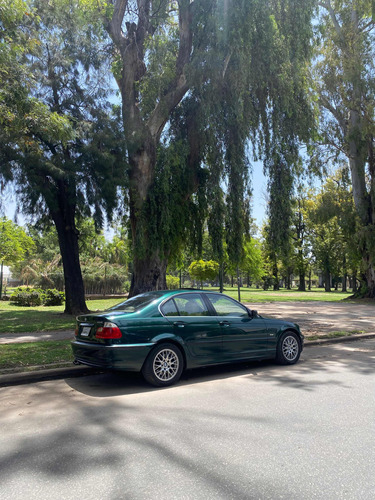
left=102, top=0, right=314, bottom=295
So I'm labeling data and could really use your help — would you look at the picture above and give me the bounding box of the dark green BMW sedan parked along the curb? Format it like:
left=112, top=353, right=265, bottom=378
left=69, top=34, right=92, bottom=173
left=72, top=290, right=303, bottom=386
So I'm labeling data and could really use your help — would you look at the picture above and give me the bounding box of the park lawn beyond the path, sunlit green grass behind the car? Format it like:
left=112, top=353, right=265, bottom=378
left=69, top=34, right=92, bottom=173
left=0, top=287, right=351, bottom=333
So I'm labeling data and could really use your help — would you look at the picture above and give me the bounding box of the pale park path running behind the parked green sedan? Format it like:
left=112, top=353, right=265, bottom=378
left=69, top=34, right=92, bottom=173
left=0, top=302, right=375, bottom=344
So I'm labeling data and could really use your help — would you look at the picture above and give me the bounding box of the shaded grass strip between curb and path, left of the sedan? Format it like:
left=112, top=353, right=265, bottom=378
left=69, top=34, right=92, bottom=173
left=0, top=340, right=74, bottom=374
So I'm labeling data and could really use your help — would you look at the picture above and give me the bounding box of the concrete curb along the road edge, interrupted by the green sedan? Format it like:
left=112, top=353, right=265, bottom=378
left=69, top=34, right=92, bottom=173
left=0, top=333, right=375, bottom=387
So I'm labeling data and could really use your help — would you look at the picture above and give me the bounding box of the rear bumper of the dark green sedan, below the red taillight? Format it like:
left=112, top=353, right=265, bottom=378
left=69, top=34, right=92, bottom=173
left=72, top=340, right=155, bottom=372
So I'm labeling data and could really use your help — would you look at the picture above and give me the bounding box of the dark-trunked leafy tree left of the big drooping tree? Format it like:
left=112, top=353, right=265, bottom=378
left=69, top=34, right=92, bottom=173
left=3, top=0, right=125, bottom=314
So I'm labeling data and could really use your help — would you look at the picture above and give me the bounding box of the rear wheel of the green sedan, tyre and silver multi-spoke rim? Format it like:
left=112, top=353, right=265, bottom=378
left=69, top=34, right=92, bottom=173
left=142, top=343, right=184, bottom=387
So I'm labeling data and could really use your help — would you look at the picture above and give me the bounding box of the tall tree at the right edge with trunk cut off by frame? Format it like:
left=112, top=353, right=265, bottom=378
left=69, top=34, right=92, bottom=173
left=315, top=0, right=375, bottom=297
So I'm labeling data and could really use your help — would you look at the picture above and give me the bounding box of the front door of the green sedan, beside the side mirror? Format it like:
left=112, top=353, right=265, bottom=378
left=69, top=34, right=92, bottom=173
left=205, top=293, right=268, bottom=361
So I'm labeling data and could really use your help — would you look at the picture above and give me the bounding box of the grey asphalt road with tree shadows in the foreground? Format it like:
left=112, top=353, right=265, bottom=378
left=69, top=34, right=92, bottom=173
left=0, top=339, right=375, bottom=500
